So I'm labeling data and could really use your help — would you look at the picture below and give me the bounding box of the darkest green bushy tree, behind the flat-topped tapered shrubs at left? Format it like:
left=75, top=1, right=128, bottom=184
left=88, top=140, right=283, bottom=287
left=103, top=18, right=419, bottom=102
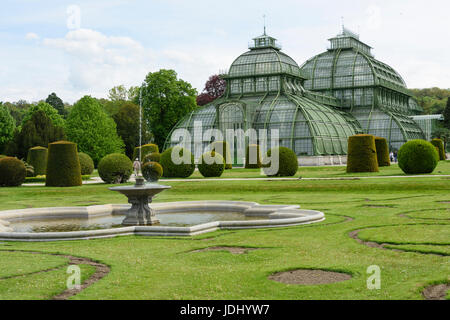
left=6, top=110, right=66, bottom=159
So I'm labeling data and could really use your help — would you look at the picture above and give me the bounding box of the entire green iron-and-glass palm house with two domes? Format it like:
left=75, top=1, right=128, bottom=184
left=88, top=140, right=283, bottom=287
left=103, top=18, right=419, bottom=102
left=165, top=29, right=424, bottom=165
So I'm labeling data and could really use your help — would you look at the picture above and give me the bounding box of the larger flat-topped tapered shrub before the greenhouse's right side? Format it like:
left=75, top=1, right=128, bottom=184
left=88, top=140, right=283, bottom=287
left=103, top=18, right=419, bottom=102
left=347, top=134, right=378, bottom=173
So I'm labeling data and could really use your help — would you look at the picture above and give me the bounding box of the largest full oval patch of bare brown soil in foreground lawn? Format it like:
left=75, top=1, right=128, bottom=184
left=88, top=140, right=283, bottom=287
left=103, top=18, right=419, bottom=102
left=269, top=269, right=352, bottom=286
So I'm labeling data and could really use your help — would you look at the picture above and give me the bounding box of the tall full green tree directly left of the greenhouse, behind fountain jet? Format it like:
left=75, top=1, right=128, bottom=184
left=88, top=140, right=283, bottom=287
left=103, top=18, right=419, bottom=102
left=140, top=69, right=197, bottom=149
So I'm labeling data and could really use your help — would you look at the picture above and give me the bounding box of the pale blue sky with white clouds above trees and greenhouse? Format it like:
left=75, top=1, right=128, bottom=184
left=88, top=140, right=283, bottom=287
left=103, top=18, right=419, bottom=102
left=0, top=0, right=450, bottom=103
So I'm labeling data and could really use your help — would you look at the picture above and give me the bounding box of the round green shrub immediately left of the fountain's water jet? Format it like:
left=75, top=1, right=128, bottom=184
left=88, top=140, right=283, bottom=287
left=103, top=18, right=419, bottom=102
left=98, top=153, right=133, bottom=184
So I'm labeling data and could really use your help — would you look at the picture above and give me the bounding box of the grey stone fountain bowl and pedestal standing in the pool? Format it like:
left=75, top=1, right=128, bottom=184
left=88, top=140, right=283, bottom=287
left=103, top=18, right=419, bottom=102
left=109, top=179, right=171, bottom=226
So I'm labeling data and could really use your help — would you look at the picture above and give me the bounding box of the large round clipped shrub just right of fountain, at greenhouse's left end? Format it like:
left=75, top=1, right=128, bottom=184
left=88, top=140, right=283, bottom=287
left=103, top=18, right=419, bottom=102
left=160, top=146, right=195, bottom=178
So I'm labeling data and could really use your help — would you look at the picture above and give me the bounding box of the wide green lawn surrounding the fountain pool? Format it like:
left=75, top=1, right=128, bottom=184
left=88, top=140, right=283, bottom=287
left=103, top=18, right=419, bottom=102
left=0, top=162, right=450, bottom=299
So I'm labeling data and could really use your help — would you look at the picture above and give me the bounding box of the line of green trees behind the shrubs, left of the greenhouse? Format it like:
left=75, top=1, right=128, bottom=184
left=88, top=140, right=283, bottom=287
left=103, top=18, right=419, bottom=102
left=0, top=69, right=225, bottom=163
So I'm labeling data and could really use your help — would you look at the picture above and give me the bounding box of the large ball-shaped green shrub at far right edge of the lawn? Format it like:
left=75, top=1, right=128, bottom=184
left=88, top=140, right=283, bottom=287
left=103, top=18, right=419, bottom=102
left=398, top=140, right=439, bottom=174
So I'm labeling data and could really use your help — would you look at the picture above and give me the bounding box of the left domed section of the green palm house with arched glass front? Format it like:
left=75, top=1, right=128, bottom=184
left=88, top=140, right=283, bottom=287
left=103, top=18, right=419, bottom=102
left=165, top=34, right=362, bottom=162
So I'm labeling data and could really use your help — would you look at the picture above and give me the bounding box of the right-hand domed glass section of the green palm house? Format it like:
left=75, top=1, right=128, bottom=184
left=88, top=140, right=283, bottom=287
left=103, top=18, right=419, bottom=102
left=301, top=28, right=425, bottom=149
